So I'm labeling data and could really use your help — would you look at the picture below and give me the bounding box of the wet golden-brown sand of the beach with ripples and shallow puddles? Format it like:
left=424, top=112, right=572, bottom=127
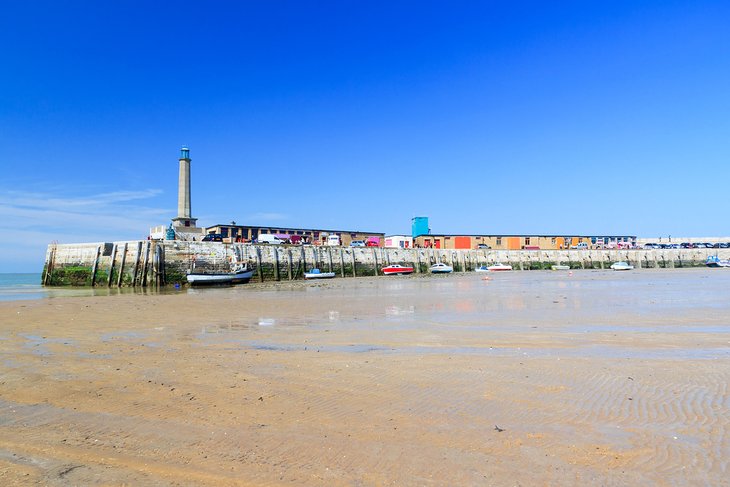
left=0, top=269, right=730, bottom=486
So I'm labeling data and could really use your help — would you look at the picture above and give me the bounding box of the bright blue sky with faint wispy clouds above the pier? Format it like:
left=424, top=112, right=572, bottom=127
left=0, top=0, right=730, bottom=272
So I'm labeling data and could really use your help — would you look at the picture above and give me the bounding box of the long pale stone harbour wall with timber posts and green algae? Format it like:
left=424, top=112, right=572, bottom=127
left=43, top=240, right=730, bottom=286
